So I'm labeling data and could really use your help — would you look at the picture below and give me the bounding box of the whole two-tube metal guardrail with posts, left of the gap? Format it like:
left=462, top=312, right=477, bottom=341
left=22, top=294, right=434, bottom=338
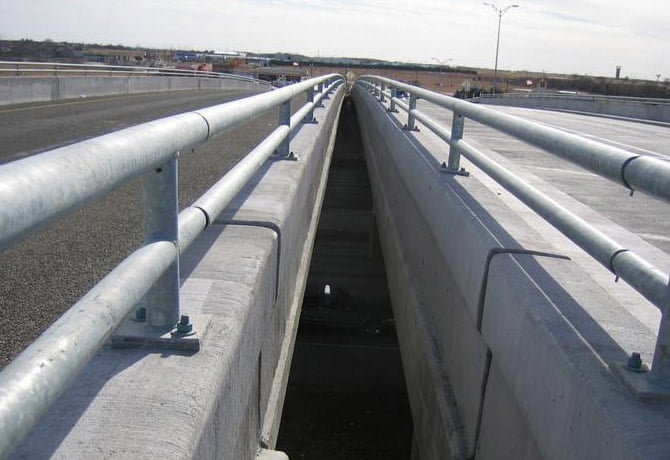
left=0, top=74, right=344, bottom=457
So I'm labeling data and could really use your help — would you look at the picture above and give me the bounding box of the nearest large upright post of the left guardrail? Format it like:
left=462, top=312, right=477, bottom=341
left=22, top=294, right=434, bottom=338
left=139, top=153, right=179, bottom=329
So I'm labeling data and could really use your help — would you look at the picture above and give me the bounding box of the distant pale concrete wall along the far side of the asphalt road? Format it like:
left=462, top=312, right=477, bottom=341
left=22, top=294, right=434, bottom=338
left=0, top=76, right=269, bottom=105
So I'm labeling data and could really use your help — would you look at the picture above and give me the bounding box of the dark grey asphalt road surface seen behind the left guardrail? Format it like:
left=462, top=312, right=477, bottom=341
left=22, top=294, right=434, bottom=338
left=0, top=90, right=278, bottom=366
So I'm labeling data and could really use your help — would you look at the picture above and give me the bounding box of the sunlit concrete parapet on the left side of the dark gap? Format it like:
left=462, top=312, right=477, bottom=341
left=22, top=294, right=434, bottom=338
left=9, top=83, right=343, bottom=459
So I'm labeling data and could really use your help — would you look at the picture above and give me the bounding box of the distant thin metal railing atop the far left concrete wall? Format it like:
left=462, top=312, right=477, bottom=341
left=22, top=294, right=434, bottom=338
left=0, top=61, right=268, bottom=84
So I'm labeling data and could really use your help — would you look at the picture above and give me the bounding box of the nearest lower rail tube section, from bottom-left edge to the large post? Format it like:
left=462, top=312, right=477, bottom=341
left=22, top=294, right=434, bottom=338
left=0, top=241, right=177, bottom=458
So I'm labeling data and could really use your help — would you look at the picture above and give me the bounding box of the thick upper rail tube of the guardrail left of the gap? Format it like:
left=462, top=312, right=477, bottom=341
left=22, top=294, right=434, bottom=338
left=0, top=75, right=342, bottom=250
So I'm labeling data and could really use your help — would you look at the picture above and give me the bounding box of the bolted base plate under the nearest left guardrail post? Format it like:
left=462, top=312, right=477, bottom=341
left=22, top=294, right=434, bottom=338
left=112, top=314, right=211, bottom=353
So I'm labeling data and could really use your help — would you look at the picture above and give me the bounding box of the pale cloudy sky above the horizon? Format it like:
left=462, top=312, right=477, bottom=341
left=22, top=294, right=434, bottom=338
left=0, top=0, right=670, bottom=81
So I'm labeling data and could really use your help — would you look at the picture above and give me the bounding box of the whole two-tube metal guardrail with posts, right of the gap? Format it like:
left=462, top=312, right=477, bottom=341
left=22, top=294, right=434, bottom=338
left=356, top=76, right=670, bottom=382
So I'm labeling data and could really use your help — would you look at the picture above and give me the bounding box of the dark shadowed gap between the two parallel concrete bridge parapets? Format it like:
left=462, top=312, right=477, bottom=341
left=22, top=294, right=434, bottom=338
left=277, top=95, right=412, bottom=460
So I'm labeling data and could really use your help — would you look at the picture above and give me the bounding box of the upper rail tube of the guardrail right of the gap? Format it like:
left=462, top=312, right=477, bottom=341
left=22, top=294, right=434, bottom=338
left=361, top=76, right=670, bottom=201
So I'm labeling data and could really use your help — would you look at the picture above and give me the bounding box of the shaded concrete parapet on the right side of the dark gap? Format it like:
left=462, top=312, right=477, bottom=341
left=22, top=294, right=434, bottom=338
left=353, top=83, right=670, bottom=460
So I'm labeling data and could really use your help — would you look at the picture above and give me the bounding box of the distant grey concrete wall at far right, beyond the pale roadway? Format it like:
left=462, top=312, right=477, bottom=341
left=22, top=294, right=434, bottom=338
left=481, top=95, right=670, bottom=123
